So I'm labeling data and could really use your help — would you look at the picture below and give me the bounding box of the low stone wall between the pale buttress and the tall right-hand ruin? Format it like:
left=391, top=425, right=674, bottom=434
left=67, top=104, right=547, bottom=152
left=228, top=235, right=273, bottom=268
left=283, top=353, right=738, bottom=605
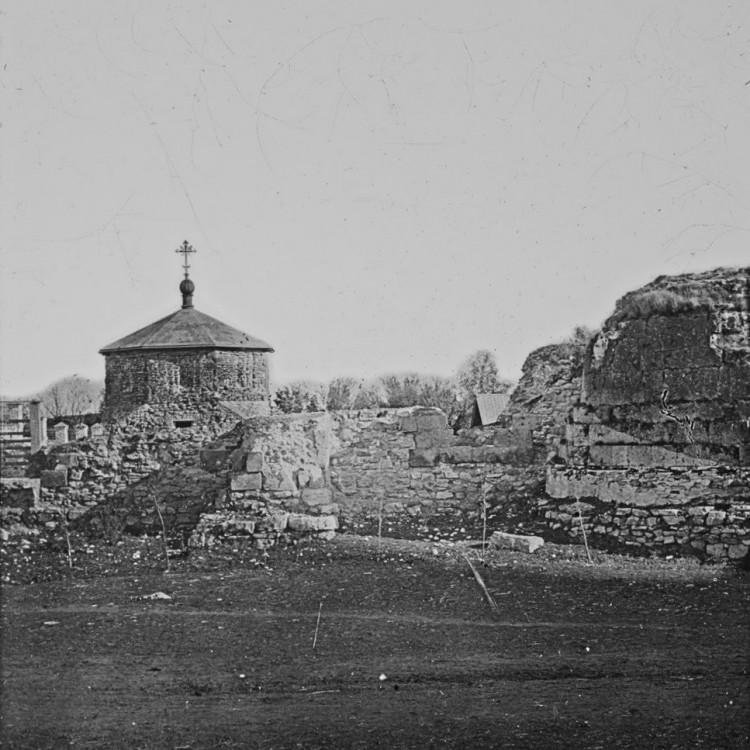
left=331, top=408, right=541, bottom=522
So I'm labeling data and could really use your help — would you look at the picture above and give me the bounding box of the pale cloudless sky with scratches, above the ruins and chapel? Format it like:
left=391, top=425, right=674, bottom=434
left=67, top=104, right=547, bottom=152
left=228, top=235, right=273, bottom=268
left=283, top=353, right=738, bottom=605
left=0, top=0, right=750, bottom=396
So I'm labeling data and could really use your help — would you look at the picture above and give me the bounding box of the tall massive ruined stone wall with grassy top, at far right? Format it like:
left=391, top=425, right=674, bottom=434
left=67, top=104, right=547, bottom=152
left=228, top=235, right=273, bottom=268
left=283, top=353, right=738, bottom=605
left=545, top=269, right=750, bottom=559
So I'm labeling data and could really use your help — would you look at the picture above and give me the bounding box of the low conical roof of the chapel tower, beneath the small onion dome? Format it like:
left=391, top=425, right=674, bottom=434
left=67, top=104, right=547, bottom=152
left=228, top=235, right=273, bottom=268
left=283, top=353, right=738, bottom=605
left=99, top=307, right=273, bottom=354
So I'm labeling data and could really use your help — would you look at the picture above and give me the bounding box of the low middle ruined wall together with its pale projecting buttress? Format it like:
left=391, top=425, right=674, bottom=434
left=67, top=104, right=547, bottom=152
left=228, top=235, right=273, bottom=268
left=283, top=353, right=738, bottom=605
left=223, top=407, right=543, bottom=536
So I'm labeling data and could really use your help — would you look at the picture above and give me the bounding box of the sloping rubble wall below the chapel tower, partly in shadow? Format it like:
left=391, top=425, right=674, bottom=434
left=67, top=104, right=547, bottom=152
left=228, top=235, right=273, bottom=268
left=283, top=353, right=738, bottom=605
left=8, top=406, right=244, bottom=536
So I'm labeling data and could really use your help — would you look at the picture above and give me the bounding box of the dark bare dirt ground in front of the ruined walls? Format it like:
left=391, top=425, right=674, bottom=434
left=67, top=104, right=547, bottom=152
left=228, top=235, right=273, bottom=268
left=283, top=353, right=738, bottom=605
left=2, top=535, right=750, bottom=750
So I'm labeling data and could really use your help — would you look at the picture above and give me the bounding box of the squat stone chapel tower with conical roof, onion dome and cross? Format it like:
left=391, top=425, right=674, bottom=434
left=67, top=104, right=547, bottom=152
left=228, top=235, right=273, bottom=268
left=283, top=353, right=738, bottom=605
left=99, top=241, right=273, bottom=417
